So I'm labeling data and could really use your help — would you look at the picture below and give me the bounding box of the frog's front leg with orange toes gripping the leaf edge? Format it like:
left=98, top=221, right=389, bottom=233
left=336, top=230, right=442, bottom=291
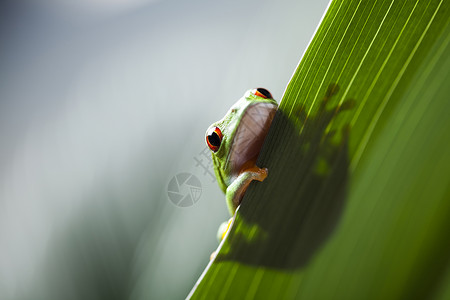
left=226, top=166, right=268, bottom=215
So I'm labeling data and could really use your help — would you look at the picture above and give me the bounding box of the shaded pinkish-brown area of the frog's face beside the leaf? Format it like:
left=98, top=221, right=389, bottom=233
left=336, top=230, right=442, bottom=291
left=228, top=102, right=277, bottom=176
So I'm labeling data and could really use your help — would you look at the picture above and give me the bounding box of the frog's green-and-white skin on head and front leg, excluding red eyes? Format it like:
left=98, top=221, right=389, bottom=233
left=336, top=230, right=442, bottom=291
left=207, top=89, right=278, bottom=215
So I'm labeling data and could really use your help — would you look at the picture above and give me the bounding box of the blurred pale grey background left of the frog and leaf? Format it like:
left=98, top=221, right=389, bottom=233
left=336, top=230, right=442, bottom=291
left=0, top=0, right=328, bottom=299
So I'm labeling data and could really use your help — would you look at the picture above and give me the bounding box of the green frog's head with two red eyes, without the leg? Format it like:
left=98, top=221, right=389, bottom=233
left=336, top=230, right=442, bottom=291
left=206, top=88, right=277, bottom=192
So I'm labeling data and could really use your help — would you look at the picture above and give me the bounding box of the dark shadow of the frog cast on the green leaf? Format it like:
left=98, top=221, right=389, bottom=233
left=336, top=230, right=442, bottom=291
left=216, top=84, right=354, bottom=269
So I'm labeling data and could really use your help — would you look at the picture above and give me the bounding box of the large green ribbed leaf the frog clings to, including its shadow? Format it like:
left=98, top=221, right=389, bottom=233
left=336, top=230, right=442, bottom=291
left=190, top=0, right=450, bottom=299
